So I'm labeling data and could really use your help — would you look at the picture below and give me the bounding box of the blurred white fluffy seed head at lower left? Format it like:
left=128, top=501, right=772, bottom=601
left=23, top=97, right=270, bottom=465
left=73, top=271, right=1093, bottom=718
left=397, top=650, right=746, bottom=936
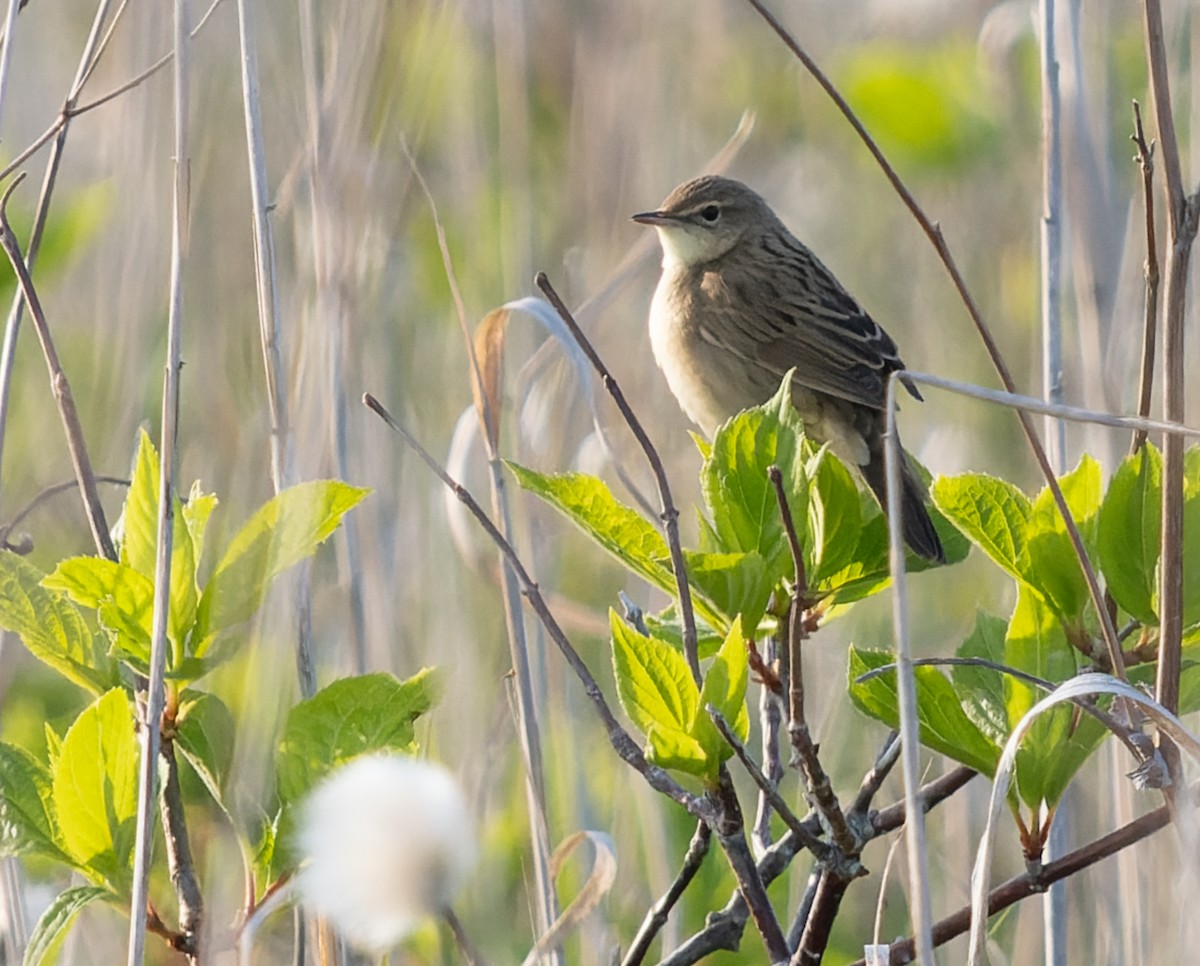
left=298, top=755, right=475, bottom=953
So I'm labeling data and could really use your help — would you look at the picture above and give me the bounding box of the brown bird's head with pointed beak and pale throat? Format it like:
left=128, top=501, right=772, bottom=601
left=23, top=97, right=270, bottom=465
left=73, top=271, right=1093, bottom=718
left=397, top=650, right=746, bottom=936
left=634, top=174, right=775, bottom=268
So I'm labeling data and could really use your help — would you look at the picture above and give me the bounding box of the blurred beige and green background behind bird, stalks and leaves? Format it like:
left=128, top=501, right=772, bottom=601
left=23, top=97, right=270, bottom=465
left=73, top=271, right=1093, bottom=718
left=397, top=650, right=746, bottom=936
left=0, top=0, right=1200, bottom=964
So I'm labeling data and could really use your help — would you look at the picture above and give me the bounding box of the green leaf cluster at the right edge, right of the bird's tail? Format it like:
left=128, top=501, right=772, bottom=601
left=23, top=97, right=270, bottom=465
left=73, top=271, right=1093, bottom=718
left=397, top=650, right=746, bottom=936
left=850, top=444, right=1200, bottom=821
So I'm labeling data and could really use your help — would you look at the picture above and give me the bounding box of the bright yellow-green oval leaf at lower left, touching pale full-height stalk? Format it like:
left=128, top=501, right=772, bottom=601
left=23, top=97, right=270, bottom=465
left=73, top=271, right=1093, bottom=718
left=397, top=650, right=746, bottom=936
left=53, top=688, right=138, bottom=895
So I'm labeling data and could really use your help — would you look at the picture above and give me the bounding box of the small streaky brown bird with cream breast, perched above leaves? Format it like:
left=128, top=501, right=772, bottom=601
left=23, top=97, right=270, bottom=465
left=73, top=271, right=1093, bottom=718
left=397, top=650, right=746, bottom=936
left=634, top=175, right=946, bottom=562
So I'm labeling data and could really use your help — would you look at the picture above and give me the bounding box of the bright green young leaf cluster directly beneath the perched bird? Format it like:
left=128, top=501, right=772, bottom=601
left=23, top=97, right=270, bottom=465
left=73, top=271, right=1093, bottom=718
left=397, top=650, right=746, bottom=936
left=510, top=378, right=967, bottom=781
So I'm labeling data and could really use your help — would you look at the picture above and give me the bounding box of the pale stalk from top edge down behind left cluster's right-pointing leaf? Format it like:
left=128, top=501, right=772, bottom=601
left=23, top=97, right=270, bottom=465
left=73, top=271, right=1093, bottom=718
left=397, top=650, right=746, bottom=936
left=238, top=0, right=293, bottom=493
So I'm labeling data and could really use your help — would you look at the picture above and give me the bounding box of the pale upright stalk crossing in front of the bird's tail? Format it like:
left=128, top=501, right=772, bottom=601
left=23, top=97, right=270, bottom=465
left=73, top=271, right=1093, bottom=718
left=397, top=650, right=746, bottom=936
left=883, top=378, right=936, bottom=966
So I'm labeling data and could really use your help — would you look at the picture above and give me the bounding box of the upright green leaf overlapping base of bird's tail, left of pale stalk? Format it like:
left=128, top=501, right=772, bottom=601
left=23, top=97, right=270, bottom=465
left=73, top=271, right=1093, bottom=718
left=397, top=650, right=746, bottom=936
left=804, top=446, right=869, bottom=587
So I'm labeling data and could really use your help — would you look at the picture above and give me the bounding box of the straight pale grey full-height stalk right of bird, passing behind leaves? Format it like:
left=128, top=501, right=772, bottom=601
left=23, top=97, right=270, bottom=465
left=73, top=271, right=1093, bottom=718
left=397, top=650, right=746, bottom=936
left=1039, top=0, right=1069, bottom=966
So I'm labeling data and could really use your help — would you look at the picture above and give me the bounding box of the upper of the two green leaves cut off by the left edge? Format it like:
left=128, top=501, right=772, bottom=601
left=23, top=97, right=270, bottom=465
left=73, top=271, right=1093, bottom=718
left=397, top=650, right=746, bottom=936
left=0, top=551, right=118, bottom=694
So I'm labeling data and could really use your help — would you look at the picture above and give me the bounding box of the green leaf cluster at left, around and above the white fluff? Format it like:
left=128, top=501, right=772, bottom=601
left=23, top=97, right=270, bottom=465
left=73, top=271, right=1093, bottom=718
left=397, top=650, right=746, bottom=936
left=0, top=433, right=437, bottom=964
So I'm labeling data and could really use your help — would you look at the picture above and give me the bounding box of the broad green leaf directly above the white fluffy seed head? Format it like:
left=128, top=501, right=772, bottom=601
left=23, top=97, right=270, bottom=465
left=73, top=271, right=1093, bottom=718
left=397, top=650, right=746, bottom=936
left=276, top=668, right=439, bottom=804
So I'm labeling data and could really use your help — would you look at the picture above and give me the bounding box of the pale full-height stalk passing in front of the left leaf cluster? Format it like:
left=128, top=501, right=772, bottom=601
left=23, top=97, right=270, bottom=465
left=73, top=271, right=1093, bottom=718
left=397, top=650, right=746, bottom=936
left=128, top=0, right=190, bottom=966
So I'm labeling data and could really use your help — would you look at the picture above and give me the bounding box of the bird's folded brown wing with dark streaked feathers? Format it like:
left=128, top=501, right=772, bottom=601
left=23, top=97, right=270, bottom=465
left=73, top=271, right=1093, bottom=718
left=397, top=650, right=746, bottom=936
left=700, top=239, right=920, bottom=409
